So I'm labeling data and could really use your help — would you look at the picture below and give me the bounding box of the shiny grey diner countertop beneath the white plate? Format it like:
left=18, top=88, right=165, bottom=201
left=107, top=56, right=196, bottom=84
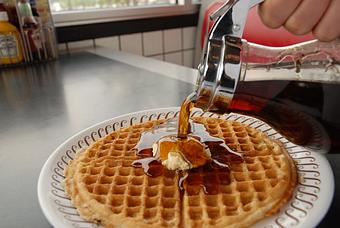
left=0, top=49, right=340, bottom=228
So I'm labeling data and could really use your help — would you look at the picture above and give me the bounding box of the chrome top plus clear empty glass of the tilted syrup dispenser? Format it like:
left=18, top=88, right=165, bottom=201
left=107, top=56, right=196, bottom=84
left=195, top=0, right=340, bottom=113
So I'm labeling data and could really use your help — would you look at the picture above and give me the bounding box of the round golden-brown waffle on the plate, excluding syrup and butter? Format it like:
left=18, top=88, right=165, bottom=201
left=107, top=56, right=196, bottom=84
left=65, top=117, right=297, bottom=227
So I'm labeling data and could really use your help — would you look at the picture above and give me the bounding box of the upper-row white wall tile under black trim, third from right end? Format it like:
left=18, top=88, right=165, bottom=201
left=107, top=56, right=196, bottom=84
left=143, top=31, right=163, bottom=56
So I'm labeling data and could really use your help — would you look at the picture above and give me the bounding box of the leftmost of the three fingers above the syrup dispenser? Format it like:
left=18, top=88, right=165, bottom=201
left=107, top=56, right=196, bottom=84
left=258, top=0, right=301, bottom=28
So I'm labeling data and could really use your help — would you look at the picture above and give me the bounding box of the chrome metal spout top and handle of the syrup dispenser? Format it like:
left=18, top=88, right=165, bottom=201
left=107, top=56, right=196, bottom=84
left=195, top=0, right=263, bottom=110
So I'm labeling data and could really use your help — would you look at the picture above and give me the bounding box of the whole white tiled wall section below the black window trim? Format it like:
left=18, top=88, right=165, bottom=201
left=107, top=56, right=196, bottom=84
left=58, top=27, right=196, bottom=67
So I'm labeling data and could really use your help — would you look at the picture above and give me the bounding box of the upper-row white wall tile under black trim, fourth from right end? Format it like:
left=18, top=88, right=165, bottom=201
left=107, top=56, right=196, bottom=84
left=120, top=33, right=143, bottom=55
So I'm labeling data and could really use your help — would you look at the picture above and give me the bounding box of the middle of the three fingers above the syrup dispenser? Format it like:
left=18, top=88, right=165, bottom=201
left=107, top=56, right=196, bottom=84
left=284, top=0, right=330, bottom=35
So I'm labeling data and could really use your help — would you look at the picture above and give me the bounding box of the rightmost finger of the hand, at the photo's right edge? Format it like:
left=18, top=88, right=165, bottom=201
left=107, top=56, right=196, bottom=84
left=313, top=0, right=340, bottom=41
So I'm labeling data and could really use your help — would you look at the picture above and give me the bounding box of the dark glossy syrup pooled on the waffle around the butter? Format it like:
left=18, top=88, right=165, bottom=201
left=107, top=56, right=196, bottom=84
left=132, top=119, right=243, bottom=194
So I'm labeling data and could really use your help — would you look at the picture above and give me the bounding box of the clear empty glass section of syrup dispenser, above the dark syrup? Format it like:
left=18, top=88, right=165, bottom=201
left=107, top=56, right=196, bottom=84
left=240, top=39, right=340, bottom=83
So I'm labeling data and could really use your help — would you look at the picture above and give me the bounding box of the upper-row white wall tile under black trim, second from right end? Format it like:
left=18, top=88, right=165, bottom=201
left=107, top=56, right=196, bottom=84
left=164, top=28, right=182, bottom=52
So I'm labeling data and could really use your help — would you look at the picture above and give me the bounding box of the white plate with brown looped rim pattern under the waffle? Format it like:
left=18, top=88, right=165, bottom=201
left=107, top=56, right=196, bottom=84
left=38, top=108, right=334, bottom=228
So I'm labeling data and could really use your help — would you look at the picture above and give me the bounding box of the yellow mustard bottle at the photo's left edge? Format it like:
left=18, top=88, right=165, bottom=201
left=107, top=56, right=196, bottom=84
left=0, top=11, right=23, bottom=64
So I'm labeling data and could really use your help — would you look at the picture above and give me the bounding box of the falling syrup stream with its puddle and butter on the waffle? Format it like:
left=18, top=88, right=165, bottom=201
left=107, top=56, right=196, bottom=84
left=133, top=94, right=243, bottom=193
